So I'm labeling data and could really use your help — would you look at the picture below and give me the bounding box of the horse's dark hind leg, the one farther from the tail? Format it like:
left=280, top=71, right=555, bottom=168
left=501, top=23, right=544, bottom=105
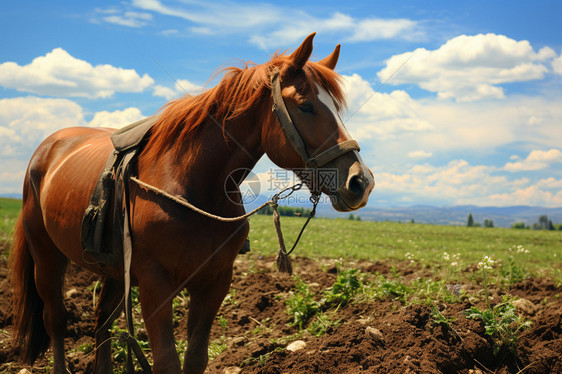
left=94, top=278, right=123, bottom=374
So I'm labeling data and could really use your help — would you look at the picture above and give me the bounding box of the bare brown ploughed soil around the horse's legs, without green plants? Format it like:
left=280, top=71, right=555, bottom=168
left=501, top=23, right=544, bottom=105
left=0, top=256, right=562, bottom=374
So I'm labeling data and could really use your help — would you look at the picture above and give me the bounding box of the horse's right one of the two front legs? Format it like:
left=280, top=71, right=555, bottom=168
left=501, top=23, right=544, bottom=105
left=183, top=267, right=232, bottom=374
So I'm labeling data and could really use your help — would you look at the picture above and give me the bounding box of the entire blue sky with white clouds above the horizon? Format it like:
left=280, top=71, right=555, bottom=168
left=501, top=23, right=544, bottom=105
left=0, top=0, right=562, bottom=207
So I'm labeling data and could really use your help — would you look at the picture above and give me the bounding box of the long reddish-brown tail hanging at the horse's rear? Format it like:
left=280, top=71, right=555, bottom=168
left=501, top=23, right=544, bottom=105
left=9, top=214, right=50, bottom=364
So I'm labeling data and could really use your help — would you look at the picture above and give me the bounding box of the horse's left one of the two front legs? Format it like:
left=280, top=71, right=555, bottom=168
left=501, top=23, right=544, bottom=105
left=138, top=269, right=181, bottom=374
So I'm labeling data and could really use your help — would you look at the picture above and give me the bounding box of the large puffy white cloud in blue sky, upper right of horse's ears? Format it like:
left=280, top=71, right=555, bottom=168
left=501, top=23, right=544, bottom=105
left=378, top=34, right=555, bottom=102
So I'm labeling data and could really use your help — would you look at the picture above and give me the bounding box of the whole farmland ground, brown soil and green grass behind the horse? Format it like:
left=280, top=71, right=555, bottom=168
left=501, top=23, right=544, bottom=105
left=0, top=199, right=562, bottom=373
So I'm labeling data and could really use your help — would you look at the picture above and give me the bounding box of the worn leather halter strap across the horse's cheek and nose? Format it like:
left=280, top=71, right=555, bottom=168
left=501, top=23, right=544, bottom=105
left=271, top=68, right=360, bottom=169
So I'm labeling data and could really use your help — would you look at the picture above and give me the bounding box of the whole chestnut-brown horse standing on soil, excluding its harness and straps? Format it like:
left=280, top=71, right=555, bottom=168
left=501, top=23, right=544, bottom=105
left=11, top=34, right=374, bottom=374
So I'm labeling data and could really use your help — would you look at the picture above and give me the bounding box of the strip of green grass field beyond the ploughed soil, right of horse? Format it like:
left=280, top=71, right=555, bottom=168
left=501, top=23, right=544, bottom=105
left=250, top=216, right=562, bottom=271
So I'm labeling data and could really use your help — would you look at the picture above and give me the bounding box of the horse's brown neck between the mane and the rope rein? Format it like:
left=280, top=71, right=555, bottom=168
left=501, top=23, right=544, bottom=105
left=139, top=111, right=263, bottom=209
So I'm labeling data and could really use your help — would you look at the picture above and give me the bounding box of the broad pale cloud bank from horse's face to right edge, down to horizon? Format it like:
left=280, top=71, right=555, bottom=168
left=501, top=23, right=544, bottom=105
left=332, top=68, right=562, bottom=206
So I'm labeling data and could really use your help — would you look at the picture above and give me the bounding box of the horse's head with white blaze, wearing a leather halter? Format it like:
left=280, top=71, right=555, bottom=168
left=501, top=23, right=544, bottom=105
left=262, top=34, right=375, bottom=212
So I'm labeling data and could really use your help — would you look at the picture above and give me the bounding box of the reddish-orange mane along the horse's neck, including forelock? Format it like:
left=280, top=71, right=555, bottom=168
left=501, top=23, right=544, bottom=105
left=150, top=54, right=345, bottom=154
